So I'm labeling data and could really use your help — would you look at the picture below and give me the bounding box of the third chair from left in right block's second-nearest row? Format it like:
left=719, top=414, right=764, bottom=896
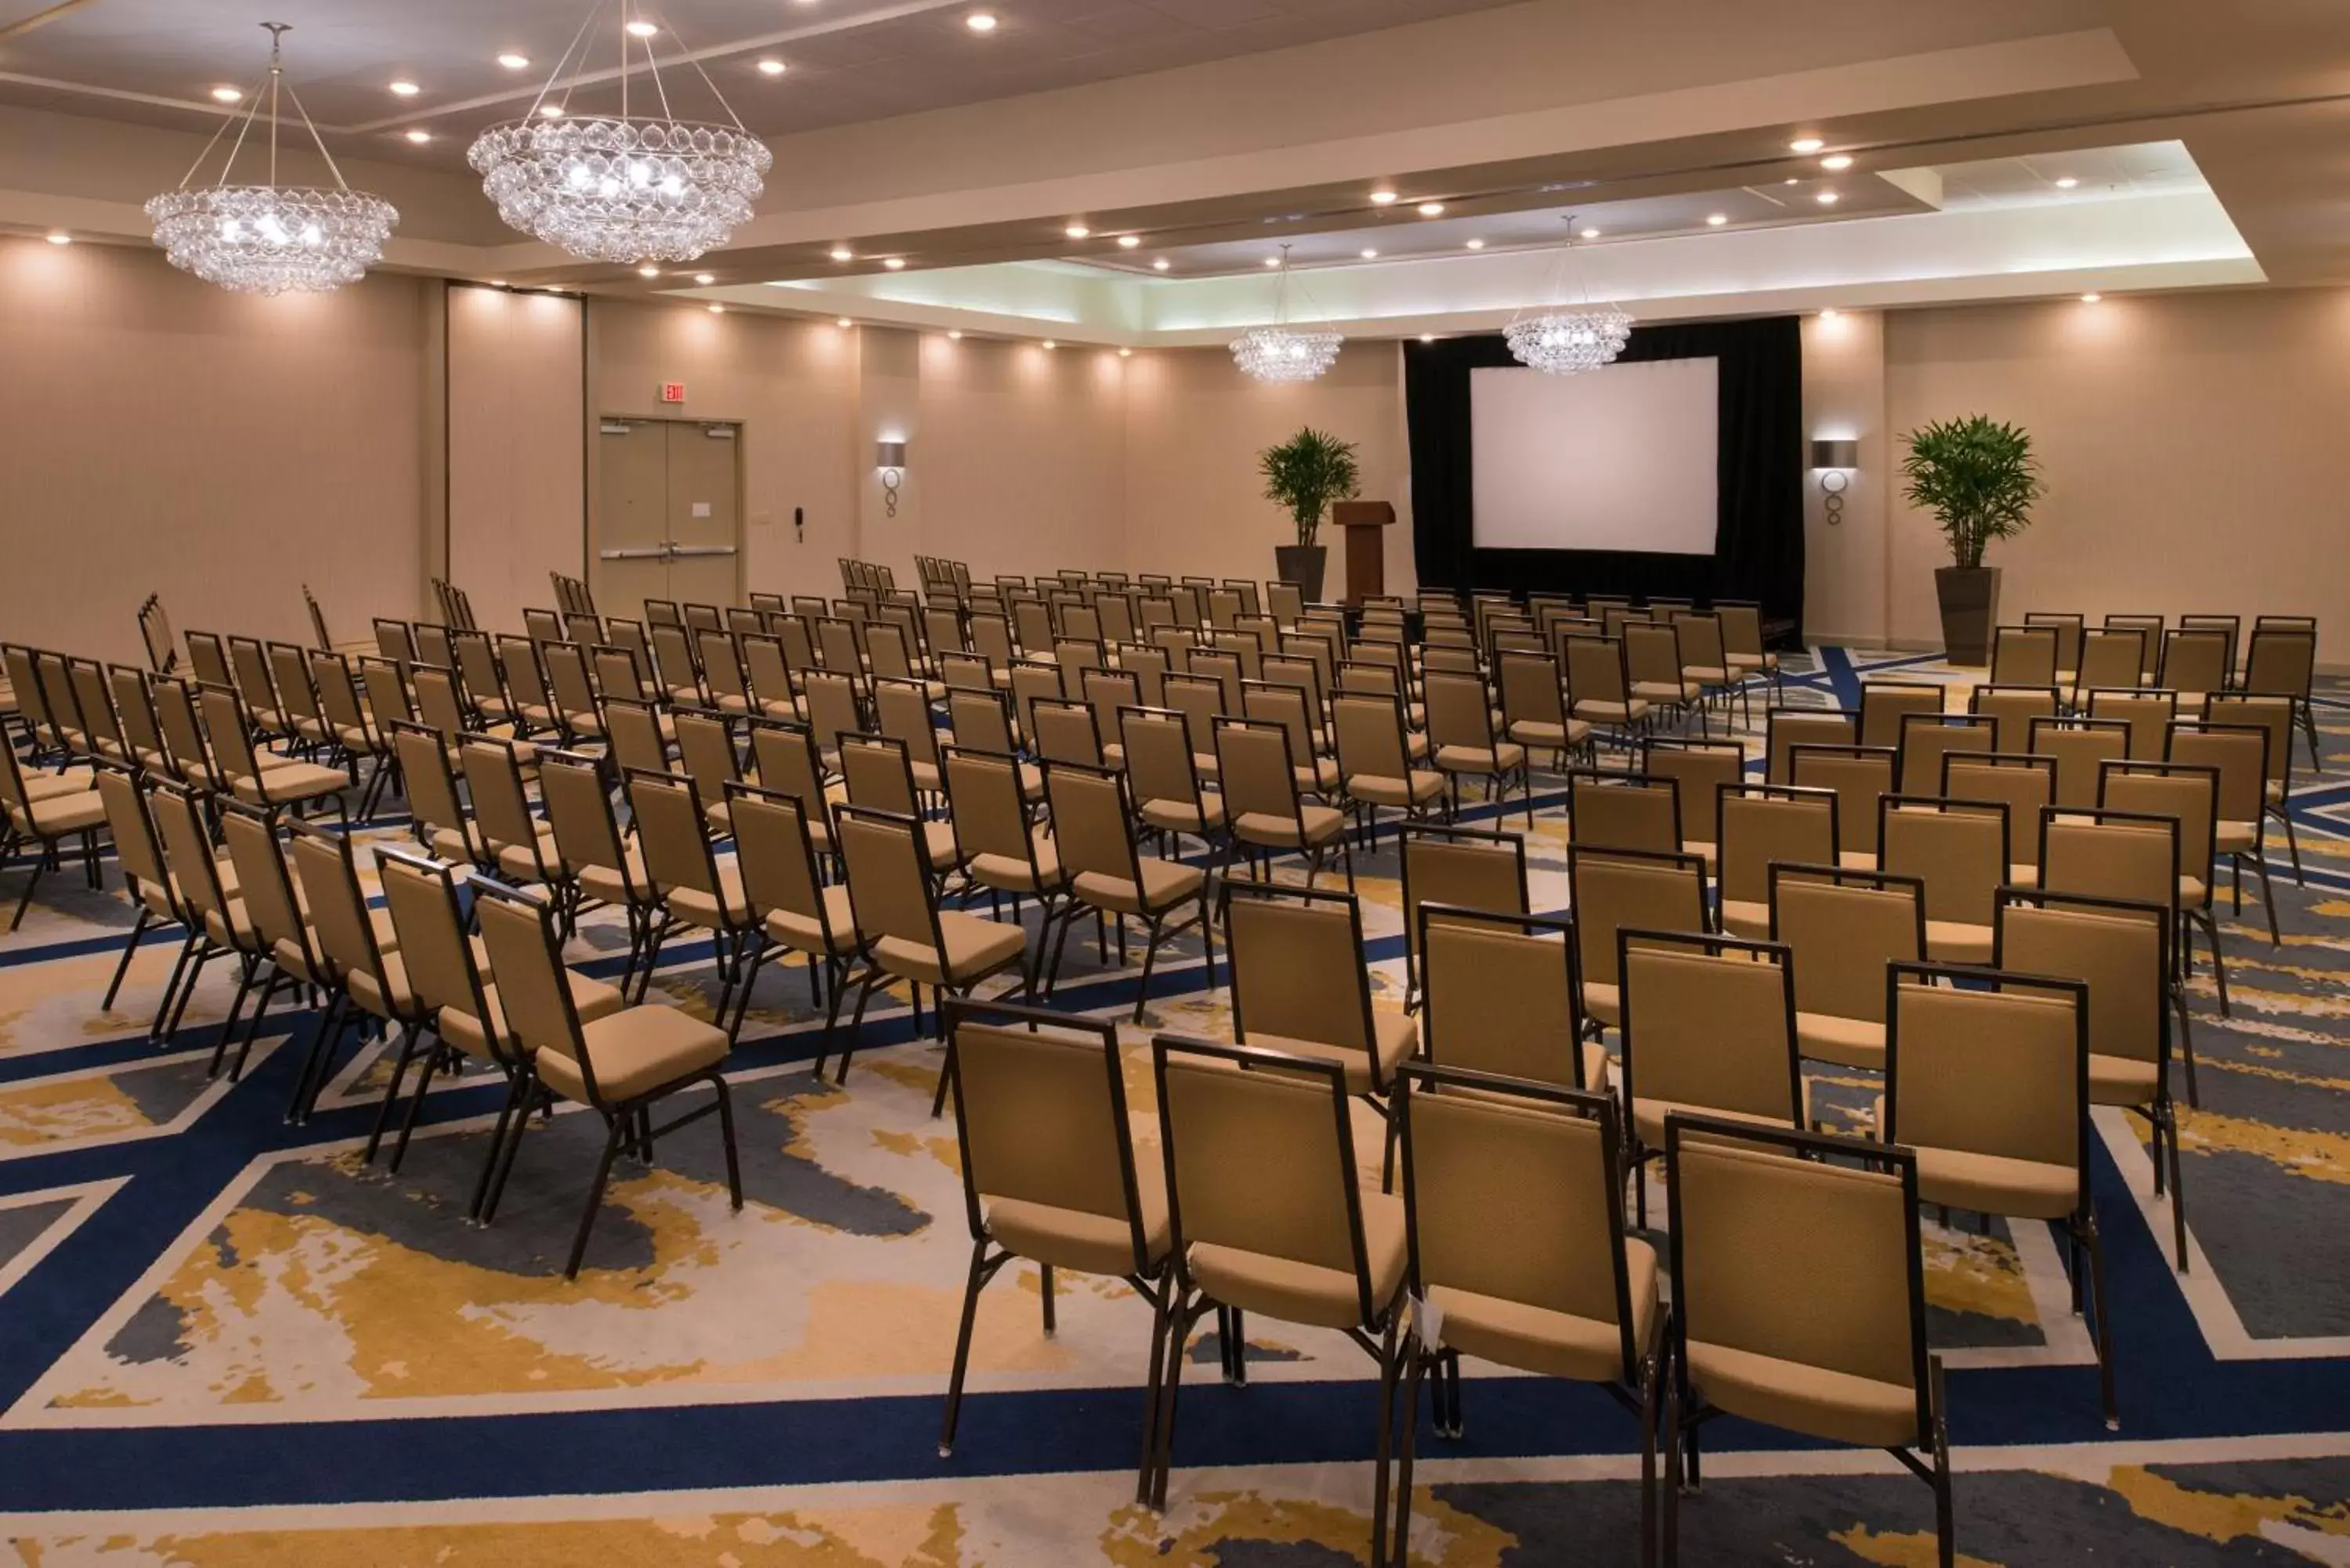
left=1617, top=927, right=1812, bottom=1230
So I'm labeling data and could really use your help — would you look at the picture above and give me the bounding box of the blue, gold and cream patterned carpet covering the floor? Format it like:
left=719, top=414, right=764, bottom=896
left=0, top=649, right=2350, bottom=1568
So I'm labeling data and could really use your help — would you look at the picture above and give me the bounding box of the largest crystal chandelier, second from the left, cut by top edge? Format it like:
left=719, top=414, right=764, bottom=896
left=465, top=0, right=776, bottom=261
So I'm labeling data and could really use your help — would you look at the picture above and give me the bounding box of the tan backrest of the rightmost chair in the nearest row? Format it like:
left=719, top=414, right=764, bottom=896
left=1664, top=1115, right=1934, bottom=1446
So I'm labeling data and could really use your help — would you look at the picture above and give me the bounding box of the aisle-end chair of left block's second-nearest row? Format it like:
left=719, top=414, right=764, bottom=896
left=841, top=807, right=1036, bottom=1117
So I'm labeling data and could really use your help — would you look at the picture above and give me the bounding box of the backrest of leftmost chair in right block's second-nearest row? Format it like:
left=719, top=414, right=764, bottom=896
left=1220, top=882, right=1384, bottom=1067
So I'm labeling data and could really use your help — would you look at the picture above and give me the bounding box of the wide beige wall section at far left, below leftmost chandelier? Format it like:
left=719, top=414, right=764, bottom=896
left=0, top=240, right=437, bottom=663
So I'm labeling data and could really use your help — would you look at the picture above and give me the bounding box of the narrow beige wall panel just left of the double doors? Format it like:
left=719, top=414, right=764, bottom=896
left=446, top=287, right=588, bottom=637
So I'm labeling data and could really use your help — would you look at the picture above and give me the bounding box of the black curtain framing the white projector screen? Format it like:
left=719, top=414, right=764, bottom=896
left=1403, top=315, right=1802, bottom=634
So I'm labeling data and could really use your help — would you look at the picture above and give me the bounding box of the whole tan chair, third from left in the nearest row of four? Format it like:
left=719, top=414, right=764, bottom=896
left=1394, top=1065, right=1668, bottom=1563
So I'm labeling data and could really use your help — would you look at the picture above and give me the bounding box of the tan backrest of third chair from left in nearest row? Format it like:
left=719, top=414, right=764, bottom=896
left=1396, top=1068, right=1645, bottom=1382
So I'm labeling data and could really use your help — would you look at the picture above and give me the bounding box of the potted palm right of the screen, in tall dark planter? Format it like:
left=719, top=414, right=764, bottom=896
left=1901, top=414, right=2047, bottom=665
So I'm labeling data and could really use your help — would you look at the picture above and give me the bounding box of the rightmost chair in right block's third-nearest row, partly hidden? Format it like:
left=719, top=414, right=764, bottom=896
left=1995, top=889, right=2188, bottom=1274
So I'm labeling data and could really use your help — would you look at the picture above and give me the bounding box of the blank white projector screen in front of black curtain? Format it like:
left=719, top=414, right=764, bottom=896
left=1469, top=357, right=1720, bottom=555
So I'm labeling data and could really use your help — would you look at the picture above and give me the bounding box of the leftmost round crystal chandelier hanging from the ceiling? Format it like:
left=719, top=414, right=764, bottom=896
left=146, top=21, right=400, bottom=294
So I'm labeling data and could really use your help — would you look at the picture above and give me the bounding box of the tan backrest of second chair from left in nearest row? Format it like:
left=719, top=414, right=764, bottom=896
left=1152, top=1035, right=1386, bottom=1328
